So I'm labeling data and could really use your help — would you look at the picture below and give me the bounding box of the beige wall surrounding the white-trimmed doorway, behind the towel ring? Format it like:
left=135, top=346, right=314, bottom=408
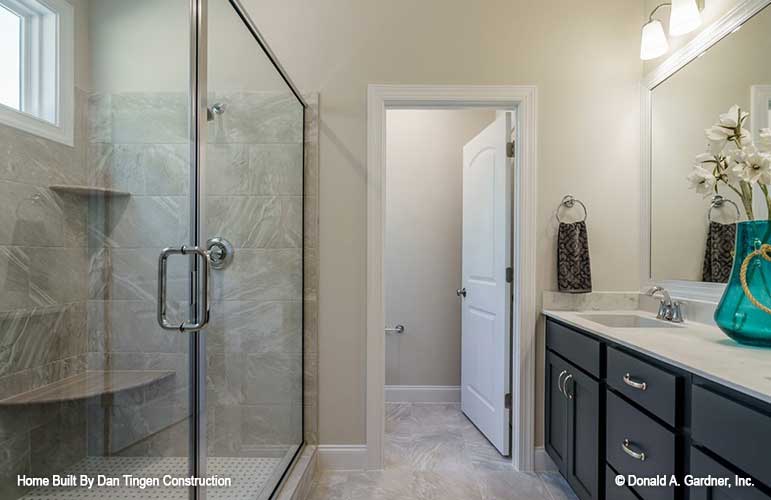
left=244, top=0, right=643, bottom=444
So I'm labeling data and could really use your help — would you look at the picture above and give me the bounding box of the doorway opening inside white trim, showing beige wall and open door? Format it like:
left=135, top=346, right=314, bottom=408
left=384, top=108, right=514, bottom=460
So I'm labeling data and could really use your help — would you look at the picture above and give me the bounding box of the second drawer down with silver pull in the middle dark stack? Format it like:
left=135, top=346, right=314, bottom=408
left=605, top=390, right=677, bottom=500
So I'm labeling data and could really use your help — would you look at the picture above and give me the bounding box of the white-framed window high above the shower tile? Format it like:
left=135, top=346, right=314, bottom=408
left=0, top=0, right=74, bottom=145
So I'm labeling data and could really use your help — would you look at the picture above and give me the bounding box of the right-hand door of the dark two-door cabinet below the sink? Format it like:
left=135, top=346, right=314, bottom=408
left=564, top=366, right=600, bottom=500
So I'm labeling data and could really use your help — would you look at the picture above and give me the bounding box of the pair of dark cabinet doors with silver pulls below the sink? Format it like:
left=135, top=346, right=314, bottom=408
left=545, top=330, right=601, bottom=500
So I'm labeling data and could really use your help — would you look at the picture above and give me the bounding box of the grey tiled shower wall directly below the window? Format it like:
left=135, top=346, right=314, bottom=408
left=0, top=89, right=87, bottom=499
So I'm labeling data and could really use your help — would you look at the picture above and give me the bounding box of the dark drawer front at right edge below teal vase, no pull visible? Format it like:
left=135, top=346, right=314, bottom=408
left=691, top=382, right=771, bottom=486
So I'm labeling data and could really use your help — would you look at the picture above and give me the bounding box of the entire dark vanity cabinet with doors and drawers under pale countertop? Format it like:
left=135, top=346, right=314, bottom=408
left=545, top=318, right=771, bottom=500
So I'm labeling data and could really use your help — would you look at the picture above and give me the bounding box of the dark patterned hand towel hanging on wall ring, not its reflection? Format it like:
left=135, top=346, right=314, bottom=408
left=557, top=221, right=592, bottom=293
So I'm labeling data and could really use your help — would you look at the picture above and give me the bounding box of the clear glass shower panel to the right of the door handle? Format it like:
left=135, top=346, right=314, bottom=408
left=203, top=0, right=303, bottom=499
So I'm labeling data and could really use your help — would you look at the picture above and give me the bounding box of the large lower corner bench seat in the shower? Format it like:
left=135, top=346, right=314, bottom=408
left=0, top=370, right=175, bottom=407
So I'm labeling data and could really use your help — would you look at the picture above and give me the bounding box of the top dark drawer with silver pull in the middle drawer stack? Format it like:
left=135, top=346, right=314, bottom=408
left=607, top=347, right=677, bottom=427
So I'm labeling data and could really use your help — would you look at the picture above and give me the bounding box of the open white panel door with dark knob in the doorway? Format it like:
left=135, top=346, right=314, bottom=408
left=461, top=113, right=512, bottom=455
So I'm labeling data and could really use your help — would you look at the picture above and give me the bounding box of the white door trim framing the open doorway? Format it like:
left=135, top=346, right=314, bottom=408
left=366, top=85, right=538, bottom=471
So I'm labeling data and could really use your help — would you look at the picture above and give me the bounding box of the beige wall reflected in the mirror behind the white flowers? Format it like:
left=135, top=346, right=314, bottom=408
left=651, top=4, right=771, bottom=281
